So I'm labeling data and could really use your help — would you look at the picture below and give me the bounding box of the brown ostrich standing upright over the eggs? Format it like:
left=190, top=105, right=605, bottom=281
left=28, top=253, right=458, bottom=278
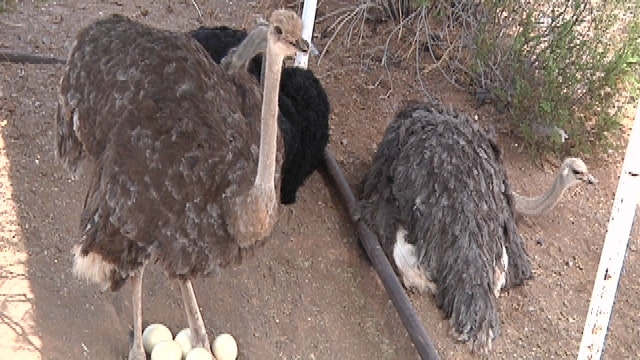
left=56, top=10, right=308, bottom=360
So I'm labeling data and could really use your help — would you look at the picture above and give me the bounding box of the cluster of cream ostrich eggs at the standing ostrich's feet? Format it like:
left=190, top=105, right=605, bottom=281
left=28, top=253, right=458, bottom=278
left=142, top=324, right=238, bottom=360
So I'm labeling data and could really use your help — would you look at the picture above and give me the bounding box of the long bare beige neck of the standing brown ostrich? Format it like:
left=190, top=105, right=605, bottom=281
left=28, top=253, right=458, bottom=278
left=254, top=47, right=284, bottom=189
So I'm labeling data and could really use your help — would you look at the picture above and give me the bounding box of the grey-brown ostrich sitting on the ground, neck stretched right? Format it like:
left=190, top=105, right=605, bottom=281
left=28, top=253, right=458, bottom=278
left=360, top=103, right=591, bottom=352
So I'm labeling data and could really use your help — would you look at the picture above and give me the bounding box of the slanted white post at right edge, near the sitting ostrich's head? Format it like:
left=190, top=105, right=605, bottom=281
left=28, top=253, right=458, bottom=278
left=578, top=103, right=640, bottom=360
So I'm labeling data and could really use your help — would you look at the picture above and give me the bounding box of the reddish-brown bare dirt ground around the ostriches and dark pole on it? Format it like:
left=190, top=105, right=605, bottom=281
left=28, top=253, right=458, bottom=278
left=0, top=0, right=640, bottom=360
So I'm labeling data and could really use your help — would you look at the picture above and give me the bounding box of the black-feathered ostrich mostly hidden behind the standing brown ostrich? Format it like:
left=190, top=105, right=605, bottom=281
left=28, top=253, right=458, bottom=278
left=189, top=26, right=331, bottom=204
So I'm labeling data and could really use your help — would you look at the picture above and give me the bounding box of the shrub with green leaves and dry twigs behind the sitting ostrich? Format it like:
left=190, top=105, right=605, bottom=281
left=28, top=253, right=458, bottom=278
left=379, top=0, right=640, bottom=153
